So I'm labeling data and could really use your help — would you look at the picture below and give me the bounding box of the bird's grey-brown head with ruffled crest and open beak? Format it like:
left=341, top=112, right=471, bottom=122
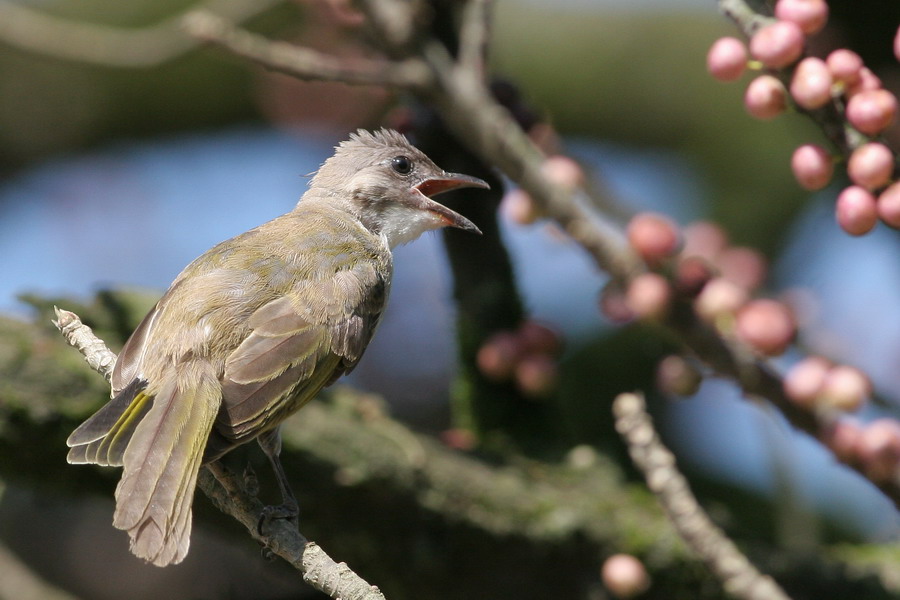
left=310, top=129, right=488, bottom=248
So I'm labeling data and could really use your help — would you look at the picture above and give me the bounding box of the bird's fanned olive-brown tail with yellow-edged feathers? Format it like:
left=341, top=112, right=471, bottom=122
left=69, top=361, right=222, bottom=566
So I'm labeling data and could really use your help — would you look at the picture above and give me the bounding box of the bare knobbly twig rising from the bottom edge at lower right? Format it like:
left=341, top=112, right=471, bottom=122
left=613, top=394, right=789, bottom=600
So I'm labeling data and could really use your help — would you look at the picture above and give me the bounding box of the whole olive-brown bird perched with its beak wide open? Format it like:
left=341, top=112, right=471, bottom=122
left=68, top=129, right=487, bottom=566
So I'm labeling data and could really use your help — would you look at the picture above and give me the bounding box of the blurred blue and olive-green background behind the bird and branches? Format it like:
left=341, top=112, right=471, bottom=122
left=0, top=0, right=900, bottom=598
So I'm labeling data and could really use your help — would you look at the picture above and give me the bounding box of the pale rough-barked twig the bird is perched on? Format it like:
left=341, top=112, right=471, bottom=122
left=54, top=308, right=384, bottom=600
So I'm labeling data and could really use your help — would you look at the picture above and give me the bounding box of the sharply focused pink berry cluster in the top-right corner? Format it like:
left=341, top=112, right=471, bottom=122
left=707, top=0, right=900, bottom=235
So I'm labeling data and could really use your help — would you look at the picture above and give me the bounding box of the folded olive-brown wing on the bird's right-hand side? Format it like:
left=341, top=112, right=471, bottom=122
left=215, top=263, right=387, bottom=443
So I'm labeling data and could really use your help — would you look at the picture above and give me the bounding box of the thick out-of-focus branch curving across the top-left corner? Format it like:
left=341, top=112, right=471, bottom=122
left=0, top=0, right=283, bottom=68
